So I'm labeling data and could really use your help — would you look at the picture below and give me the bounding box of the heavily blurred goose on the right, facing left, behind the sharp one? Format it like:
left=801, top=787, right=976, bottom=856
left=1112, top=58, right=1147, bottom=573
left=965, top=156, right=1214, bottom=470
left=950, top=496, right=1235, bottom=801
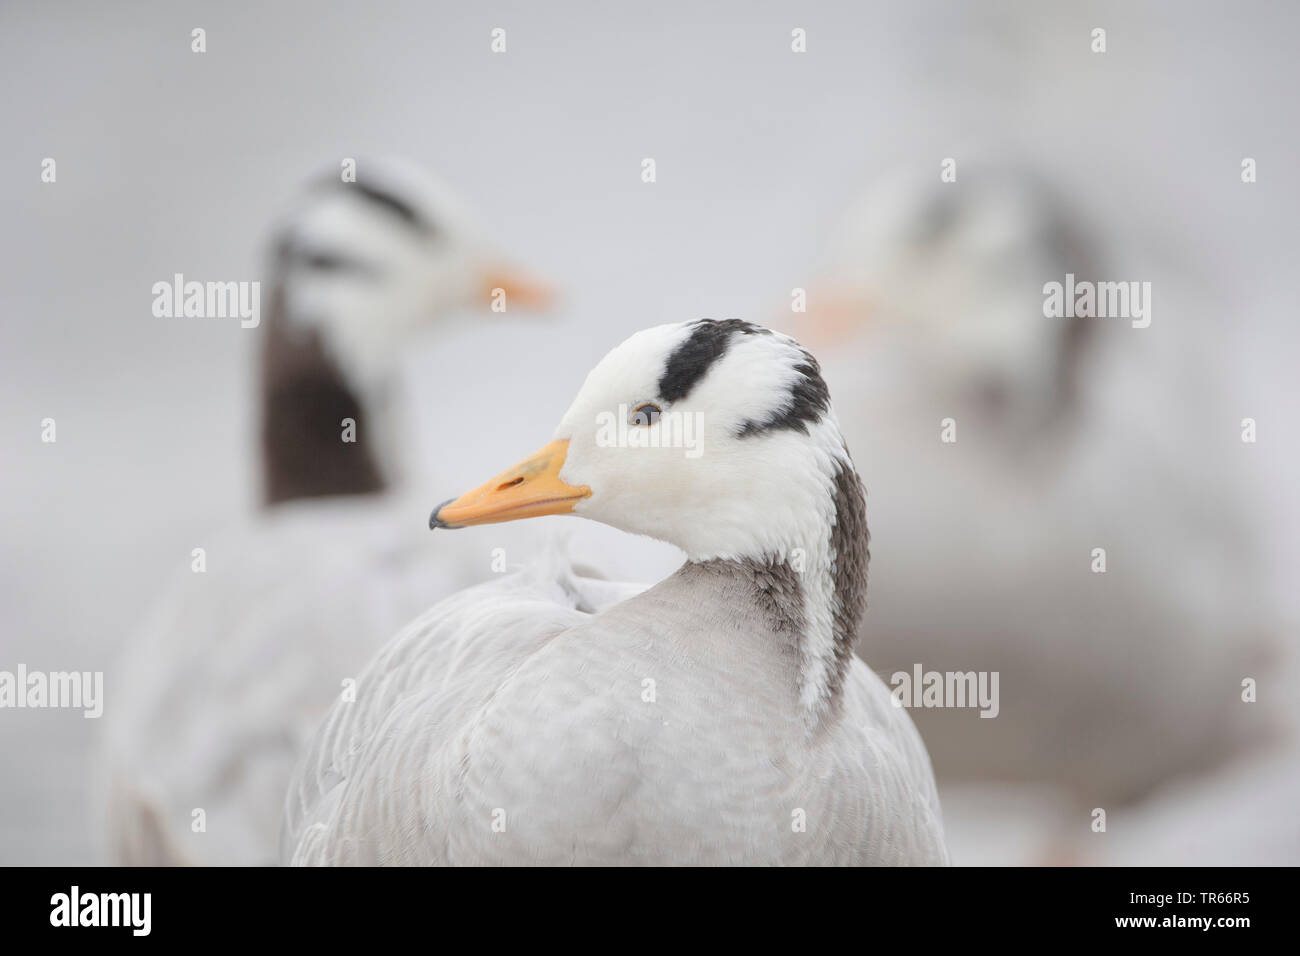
left=800, top=164, right=1270, bottom=822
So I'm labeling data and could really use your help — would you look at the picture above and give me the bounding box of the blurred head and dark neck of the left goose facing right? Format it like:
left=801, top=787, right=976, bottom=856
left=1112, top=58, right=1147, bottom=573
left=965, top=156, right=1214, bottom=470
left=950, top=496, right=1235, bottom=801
left=261, top=160, right=553, bottom=503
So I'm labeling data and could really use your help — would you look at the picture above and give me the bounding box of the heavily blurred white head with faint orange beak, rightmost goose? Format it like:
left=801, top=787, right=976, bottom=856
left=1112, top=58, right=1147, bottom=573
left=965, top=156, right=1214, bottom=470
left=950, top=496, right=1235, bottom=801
left=801, top=163, right=1093, bottom=425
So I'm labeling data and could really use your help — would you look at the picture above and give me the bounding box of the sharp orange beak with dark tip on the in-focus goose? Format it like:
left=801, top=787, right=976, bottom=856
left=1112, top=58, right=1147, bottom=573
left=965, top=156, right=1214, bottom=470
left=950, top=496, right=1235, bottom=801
left=429, top=438, right=592, bottom=528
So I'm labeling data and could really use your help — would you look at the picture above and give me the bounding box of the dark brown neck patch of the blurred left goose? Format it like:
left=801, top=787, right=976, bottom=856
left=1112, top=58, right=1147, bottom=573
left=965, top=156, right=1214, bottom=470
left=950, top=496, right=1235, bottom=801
left=261, top=289, right=385, bottom=505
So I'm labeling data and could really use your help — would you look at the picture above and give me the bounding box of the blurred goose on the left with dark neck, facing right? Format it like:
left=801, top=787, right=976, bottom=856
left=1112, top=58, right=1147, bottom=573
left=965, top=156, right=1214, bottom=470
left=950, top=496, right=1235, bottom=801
left=104, top=161, right=549, bottom=864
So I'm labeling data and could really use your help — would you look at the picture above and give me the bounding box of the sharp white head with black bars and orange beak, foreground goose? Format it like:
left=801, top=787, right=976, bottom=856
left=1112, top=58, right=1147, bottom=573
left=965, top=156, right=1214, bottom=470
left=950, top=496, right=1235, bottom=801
left=430, top=319, right=868, bottom=710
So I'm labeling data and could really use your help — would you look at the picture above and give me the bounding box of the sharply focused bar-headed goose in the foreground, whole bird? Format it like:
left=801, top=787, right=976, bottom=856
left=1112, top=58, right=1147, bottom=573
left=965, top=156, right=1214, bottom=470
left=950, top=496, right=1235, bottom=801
left=285, top=320, right=946, bottom=864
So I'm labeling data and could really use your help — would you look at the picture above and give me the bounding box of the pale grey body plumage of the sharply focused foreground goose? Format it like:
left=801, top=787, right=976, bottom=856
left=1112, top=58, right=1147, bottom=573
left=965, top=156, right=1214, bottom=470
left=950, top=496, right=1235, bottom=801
left=285, top=562, right=946, bottom=864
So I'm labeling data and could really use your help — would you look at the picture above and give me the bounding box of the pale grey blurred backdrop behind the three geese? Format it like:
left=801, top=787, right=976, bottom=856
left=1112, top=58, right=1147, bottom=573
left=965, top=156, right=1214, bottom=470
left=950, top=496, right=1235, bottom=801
left=0, top=1, right=1300, bottom=864
